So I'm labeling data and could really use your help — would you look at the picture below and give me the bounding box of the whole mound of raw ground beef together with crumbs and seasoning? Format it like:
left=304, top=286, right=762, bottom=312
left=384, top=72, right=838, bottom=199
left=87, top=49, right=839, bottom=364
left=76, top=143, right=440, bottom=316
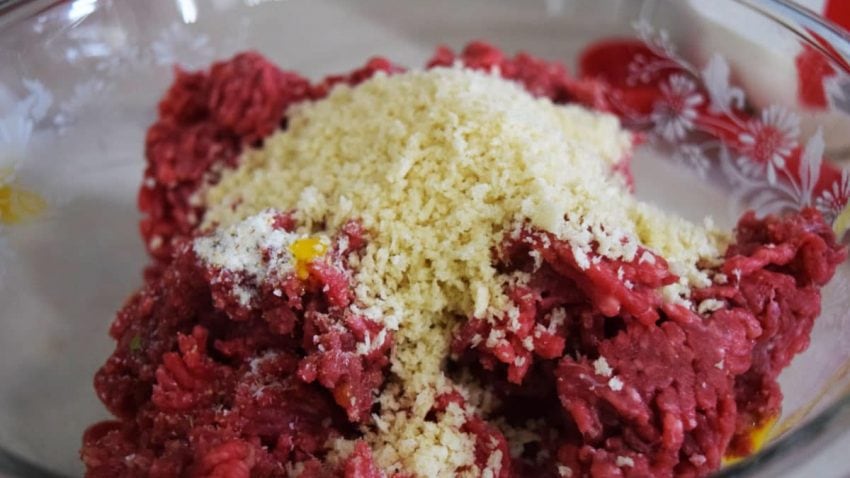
left=81, top=42, right=846, bottom=478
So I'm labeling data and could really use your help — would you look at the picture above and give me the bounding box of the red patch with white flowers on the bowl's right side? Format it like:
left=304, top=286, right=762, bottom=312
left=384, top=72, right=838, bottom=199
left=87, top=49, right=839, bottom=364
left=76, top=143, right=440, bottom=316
left=579, top=35, right=846, bottom=222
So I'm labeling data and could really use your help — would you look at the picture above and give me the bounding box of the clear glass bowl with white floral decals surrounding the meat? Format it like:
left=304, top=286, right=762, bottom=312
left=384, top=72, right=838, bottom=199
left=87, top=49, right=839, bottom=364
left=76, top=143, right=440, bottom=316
left=0, top=0, right=850, bottom=477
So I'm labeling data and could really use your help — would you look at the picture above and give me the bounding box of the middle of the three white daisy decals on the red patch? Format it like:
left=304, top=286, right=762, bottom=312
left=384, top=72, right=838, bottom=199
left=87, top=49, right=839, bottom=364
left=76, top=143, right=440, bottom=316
left=738, top=105, right=800, bottom=184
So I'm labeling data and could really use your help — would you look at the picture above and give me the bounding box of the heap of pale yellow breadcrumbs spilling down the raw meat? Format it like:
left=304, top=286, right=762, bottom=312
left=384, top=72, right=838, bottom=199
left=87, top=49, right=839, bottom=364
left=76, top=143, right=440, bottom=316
left=203, top=68, right=722, bottom=476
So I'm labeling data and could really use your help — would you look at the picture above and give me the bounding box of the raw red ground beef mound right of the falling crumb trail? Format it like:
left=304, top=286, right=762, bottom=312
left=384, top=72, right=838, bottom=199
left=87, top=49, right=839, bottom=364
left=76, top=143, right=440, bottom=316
left=453, top=209, right=846, bottom=477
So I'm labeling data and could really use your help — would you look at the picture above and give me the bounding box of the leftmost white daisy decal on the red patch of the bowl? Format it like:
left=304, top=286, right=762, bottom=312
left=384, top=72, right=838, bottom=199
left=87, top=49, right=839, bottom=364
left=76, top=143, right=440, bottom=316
left=651, top=75, right=703, bottom=141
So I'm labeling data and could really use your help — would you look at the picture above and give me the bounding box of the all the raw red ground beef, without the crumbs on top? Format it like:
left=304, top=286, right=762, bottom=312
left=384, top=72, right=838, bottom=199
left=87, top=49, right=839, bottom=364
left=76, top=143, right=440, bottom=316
left=81, top=42, right=846, bottom=478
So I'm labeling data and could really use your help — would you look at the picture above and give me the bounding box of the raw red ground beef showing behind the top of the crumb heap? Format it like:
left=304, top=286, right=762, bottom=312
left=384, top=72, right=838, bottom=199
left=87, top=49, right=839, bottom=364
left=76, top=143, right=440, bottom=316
left=138, top=42, right=632, bottom=274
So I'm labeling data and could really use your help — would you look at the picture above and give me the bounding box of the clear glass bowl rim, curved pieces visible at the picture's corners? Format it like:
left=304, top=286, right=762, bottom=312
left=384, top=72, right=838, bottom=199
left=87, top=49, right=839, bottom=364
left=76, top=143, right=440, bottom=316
left=0, top=0, right=850, bottom=478
